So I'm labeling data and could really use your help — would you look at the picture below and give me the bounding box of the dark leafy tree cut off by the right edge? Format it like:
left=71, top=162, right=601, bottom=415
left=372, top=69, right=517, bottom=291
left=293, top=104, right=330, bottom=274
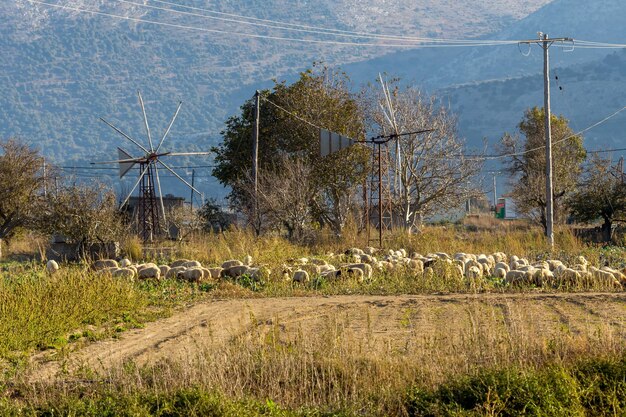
left=568, top=154, right=626, bottom=242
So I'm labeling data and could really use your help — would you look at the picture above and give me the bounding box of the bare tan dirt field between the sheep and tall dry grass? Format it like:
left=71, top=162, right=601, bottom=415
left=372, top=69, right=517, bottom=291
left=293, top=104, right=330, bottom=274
left=32, top=293, right=626, bottom=381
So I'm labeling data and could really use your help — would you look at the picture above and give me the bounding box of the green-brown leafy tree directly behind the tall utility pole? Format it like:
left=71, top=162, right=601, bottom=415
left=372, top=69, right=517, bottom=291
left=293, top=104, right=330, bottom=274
left=501, top=107, right=586, bottom=230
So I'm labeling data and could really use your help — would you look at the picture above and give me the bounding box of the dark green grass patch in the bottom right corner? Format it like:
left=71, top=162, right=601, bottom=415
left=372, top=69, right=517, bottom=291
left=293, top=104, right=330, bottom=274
left=407, top=356, right=626, bottom=417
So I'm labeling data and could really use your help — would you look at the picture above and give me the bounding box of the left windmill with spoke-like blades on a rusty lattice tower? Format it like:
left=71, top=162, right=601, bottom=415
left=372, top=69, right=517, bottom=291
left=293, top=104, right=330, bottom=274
left=92, top=91, right=210, bottom=242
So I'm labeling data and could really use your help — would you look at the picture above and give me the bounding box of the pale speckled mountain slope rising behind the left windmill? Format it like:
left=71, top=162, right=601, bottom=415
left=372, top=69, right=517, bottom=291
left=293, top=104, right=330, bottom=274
left=0, top=0, right=548, bottom=196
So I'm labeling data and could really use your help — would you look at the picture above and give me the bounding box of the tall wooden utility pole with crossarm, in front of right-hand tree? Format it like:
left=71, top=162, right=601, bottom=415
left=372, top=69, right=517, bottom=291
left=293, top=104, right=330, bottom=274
left=520, top=32, right=574, bottom=248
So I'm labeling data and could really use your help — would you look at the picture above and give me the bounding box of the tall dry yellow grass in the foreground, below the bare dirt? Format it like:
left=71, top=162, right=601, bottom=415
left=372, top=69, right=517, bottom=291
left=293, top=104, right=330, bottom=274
left=26, top=299, right=626, bottom=415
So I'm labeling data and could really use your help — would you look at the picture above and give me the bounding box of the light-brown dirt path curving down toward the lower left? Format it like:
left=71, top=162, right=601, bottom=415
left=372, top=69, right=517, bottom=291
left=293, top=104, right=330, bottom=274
left=31, top=293, right=626, bottom=381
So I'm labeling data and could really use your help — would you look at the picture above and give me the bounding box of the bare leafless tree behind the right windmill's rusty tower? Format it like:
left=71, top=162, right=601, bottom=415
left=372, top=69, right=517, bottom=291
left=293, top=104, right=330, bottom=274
left=366, top=82, right=482, bottom=232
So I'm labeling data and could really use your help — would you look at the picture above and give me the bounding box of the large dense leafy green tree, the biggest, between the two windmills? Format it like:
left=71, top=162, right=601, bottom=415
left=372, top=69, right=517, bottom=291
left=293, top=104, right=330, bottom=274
left=213, top=66, right=369, bottom=235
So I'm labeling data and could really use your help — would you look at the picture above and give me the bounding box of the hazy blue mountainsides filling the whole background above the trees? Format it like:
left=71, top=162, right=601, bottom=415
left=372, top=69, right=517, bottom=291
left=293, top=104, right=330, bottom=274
left=0, top=0, right=626, bottom=198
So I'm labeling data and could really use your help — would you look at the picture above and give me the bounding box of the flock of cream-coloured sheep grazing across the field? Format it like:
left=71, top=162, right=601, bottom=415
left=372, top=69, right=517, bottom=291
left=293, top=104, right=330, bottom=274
left=46, top=247, right=626, bottom=289
